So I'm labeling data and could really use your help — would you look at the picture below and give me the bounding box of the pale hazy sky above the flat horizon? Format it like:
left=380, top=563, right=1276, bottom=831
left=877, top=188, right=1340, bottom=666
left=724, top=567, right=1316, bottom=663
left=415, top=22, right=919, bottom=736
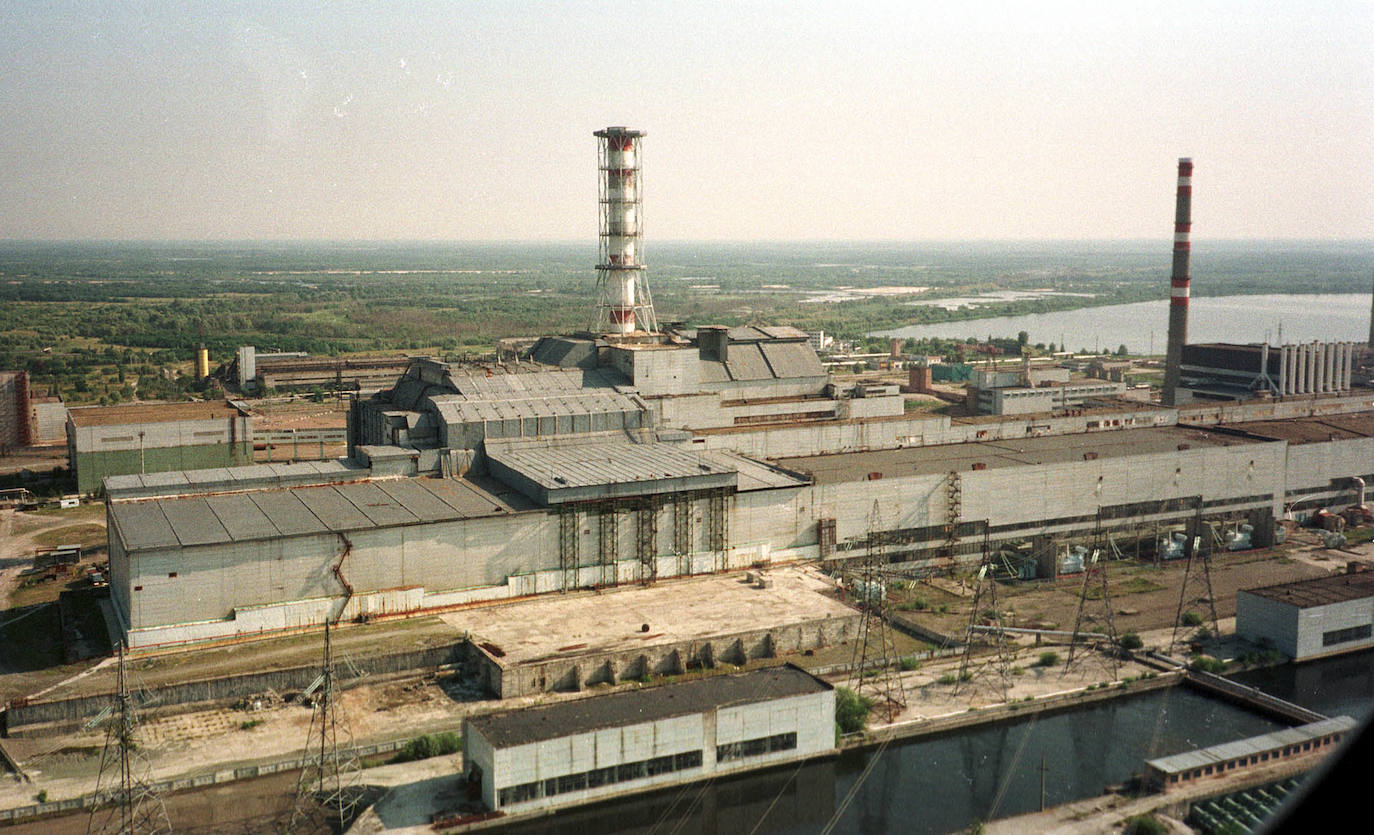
left=0, top=0, right=1374, bottom=242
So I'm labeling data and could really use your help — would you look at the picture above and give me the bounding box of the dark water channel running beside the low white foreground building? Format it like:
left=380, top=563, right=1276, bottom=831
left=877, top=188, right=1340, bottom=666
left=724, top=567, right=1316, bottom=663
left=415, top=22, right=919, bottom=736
left=500, top=651, right=1374, bottom=835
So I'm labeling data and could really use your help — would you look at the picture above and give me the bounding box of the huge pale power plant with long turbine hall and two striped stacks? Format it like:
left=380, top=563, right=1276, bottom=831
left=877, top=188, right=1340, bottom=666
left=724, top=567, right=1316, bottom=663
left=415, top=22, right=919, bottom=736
left=83, top=138, right=1374, bottom=659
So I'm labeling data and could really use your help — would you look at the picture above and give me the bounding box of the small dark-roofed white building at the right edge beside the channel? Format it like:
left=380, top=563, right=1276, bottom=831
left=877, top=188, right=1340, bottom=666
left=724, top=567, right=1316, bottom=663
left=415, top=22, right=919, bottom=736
left=1235, top=571, right=1374, bottom=661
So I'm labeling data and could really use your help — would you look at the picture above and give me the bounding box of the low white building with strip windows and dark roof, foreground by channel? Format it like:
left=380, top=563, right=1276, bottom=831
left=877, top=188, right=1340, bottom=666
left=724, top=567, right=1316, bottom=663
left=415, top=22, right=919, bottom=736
left=463, top=665, right=835, bottom=813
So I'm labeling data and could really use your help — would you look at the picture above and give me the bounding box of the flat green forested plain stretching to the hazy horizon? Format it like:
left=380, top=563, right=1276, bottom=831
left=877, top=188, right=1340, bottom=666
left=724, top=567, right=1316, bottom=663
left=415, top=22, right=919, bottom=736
left=0, top=242, right=1374, bottom=402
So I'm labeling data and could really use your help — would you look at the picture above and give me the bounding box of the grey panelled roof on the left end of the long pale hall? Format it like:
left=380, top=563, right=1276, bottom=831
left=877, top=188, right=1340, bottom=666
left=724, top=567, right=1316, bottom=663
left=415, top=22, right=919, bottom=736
left=110, top=478, right=515, bottom=551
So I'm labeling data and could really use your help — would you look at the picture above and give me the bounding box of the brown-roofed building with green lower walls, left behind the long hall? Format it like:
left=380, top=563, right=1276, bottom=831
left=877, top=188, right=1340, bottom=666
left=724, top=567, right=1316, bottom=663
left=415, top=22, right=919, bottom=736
left=66, top=401, right=253, bottom=493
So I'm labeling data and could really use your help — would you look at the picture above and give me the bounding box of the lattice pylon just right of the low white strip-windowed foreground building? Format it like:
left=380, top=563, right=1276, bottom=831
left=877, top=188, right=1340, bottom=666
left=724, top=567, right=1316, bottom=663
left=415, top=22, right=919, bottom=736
left=849, top=501, right=907, bottom=722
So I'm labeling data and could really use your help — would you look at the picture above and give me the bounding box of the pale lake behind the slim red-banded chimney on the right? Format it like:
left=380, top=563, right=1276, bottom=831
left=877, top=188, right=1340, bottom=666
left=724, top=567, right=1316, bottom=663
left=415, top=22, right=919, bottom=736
left=870, top=293, right=1370, bottom=354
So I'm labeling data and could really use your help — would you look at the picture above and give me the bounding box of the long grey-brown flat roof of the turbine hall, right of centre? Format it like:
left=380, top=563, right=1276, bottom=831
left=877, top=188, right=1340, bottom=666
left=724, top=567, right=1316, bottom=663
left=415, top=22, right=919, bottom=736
left=775, top=426, right=1260, bottom=483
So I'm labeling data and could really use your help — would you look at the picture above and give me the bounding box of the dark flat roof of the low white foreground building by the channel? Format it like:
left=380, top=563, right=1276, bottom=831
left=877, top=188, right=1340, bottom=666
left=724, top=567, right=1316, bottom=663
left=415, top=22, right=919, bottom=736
left=467, top=665, right=831, bottom=748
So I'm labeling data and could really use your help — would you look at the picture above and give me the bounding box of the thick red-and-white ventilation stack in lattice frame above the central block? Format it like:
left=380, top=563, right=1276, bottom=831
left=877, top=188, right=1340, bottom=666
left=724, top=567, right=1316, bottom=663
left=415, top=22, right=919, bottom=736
left=595, top=128, right=658, bottom=336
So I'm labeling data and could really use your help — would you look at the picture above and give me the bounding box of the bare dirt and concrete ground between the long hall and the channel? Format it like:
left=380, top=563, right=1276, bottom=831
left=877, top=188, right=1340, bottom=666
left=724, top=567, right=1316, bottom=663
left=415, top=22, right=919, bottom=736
left=0, top=521, right=1371, bottom=829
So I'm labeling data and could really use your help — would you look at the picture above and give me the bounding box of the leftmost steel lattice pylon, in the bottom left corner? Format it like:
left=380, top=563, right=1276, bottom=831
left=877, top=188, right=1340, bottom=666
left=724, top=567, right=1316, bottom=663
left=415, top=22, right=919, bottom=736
left=87, top=641, right=172, bottom=835
